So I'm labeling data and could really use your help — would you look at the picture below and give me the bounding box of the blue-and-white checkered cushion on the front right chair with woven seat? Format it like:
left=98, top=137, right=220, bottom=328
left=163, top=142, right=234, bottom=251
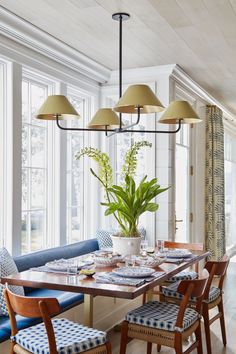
left=125, top=301, right=200, bottom=332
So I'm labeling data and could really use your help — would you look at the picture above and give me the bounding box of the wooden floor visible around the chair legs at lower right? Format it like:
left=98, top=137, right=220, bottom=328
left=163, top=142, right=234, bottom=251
left=109, top=262, right=236, bottom=354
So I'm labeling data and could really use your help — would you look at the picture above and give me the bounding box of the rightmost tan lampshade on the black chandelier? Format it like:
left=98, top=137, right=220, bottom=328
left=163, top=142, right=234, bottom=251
left=159, top=101, right=201, bottom=124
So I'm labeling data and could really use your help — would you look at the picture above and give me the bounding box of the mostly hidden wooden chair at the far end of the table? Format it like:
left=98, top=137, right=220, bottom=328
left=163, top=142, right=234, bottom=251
left=143, top=241, right=204, bottom=304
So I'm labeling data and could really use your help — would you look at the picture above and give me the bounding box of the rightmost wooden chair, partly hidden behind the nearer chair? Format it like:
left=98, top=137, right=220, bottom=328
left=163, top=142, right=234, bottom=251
left=162, top=256, right=229, bottom=354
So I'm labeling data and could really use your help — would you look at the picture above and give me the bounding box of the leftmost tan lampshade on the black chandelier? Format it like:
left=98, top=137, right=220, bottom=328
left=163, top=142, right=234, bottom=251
left=36, top=95, right=80, bottom=120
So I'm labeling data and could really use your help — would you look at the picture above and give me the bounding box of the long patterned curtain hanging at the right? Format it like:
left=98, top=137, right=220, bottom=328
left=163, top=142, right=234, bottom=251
left=205, top=106, right=225, bottom=260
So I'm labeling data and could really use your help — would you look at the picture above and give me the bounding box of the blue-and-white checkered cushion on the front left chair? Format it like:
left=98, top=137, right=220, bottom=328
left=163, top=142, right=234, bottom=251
left=12, top=318, right=106, bottom=354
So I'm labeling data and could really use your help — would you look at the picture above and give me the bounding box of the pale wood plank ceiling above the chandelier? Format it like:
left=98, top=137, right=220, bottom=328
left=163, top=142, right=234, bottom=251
left=0, top=0, right=236, bottom=114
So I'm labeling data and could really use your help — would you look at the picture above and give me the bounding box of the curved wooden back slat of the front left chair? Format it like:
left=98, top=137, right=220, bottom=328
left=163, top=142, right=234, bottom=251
left=5, top=285, right=60, bottom=318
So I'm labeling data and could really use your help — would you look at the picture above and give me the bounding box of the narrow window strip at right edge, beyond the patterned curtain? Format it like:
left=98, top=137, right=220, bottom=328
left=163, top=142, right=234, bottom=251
left=225, top=133, right=236, bottom=248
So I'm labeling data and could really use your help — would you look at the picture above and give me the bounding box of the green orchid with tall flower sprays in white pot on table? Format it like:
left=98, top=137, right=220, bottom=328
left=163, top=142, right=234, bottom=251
left=76, top=141, right=169, bottom=254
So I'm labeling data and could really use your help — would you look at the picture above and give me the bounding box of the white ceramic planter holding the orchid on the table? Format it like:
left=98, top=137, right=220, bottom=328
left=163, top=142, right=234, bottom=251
left=111, top=235, right=141, bottom=256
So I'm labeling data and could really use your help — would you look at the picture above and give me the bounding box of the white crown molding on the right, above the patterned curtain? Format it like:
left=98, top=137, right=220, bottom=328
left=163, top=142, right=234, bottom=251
left=170, top=65, right=236, bottom=124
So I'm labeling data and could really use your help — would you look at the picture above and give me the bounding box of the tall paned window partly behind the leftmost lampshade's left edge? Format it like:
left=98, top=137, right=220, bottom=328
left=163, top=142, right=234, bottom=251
left=21, top=76, right=51, bottom=253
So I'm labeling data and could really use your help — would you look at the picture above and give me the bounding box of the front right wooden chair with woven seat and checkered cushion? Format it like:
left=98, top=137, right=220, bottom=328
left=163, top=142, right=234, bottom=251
left=120, top=270, right=209, bottom=354
